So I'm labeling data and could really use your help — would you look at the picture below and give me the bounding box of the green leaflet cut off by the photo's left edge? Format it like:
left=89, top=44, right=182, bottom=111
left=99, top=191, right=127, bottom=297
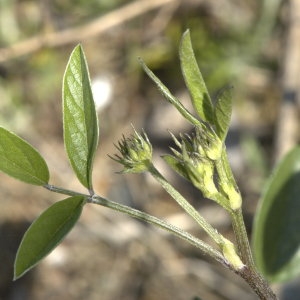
left=0, top=127, right=49, bottom=185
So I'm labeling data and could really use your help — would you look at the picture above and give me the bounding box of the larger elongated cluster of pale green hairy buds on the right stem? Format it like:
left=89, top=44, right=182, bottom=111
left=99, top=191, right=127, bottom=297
left=165, top=122, right=241, bottom=211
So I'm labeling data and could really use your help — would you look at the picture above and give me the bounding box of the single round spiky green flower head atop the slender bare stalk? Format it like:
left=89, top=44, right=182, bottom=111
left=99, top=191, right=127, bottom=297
left=110, top=129, right=152, bottom=173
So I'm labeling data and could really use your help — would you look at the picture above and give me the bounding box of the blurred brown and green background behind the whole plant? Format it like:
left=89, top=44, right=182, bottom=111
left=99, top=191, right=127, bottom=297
left=0, top=0, right=300, bottom=300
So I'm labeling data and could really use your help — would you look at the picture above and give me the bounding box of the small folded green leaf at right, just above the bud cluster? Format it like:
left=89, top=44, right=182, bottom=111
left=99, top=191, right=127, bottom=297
left=214, top=88, right=232, bottom=141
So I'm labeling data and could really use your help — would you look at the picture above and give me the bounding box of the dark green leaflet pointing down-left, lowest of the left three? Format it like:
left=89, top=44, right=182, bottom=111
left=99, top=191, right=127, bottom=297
left=14, top=196, right=85, bottom=280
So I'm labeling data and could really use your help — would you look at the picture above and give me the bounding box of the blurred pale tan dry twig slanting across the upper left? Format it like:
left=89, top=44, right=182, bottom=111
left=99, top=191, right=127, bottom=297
left=0, top=0, right=180, bottom=63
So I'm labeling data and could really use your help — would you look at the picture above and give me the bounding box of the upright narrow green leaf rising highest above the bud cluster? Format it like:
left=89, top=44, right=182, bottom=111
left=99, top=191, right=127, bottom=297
left=179, top=30, right=214, bottom=125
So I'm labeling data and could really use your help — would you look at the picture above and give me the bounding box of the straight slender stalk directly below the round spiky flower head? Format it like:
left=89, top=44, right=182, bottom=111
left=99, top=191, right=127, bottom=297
left=148, top=163, right=225, bottom=246
